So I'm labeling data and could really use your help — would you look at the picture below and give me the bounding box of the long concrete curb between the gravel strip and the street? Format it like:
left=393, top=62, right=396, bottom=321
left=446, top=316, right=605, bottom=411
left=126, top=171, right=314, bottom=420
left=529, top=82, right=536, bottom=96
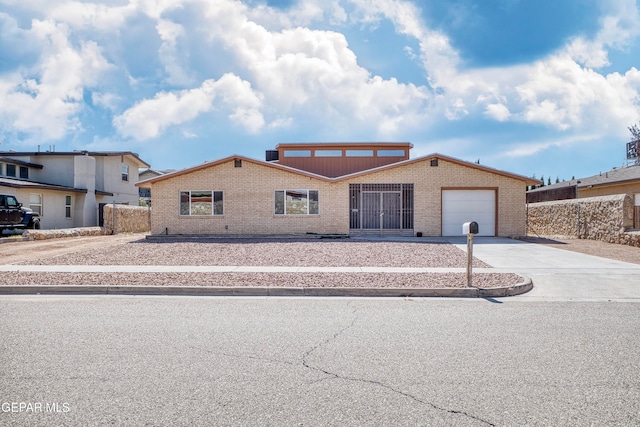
left=0, top=277, right=533, bottom=298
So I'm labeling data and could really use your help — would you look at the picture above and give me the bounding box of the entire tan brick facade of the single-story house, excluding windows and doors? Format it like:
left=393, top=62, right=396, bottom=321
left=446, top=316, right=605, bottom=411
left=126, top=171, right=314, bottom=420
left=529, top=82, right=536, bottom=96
left=145, top=157, right=527, bottom=236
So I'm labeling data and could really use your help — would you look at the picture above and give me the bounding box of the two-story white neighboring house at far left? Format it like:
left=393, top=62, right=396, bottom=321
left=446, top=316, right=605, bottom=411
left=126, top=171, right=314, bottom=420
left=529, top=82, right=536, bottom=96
left=0, top=151, right=149, bottom=229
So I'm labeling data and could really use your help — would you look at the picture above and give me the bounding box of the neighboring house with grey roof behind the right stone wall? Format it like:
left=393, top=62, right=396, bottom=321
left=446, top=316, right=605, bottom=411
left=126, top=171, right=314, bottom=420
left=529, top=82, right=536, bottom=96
left=527, top=166, right=640, bottom=229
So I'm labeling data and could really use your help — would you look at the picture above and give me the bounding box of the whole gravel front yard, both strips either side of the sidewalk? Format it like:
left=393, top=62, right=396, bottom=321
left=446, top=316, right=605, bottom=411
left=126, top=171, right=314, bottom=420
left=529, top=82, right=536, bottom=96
left=0, top=236, right=523, bottom=288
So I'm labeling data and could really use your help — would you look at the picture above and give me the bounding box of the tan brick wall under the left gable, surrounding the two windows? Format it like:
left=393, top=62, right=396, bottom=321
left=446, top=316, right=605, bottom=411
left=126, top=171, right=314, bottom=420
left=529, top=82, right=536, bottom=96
left=151, top=160, right=349, bottom=234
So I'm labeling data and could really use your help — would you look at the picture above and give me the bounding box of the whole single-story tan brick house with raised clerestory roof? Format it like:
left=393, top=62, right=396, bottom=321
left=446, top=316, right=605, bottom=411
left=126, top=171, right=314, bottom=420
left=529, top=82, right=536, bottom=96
left=136, top=143, right=537, bottom=236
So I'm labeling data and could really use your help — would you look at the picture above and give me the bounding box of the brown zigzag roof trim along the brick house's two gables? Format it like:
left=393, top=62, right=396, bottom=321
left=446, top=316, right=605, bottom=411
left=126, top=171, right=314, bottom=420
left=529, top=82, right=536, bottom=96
left=135, top=153, right=539, bottom=187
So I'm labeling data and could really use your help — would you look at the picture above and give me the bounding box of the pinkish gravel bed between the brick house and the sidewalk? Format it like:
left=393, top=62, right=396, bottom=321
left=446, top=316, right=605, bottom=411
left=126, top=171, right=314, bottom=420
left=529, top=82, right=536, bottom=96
left=22, top=239, right=490, bottom=268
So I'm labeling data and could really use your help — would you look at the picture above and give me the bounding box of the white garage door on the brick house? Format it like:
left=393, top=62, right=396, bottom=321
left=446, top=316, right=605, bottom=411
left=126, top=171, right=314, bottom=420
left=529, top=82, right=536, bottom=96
left=442, top=190, right=496, bottom=236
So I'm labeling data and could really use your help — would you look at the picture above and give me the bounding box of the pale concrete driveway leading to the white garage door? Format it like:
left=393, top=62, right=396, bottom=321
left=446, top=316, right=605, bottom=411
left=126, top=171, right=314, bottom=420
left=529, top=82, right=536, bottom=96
left=445, top=236, right=640, bottom=302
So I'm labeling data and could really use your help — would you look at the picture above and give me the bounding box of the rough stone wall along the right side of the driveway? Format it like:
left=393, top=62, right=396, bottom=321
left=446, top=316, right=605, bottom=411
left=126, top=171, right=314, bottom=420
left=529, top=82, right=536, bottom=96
left=527, top=194, right=640, bottom=247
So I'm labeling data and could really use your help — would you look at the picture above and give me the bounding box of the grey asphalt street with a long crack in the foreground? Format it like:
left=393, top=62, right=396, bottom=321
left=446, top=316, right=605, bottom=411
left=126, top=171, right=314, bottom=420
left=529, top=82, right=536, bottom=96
left=0, top=295, right=640, bottom=426
